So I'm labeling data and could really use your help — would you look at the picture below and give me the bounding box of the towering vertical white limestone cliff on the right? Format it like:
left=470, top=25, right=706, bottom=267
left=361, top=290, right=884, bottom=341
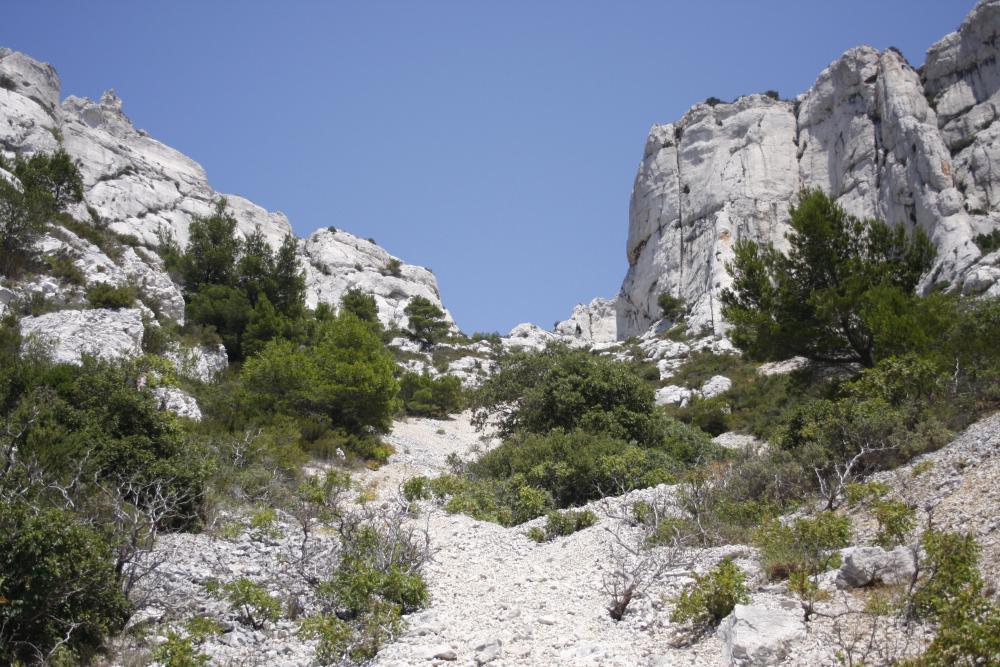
left=617, top=0, right=1000, bottom=339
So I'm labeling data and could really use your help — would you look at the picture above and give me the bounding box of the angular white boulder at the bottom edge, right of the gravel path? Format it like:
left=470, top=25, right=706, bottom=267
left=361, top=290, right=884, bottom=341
left=717, top=604, right=806, bottom=667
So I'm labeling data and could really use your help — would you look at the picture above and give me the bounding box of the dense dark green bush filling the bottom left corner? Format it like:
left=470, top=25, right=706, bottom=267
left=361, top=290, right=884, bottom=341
left=0, top=502, right=129, bottom=664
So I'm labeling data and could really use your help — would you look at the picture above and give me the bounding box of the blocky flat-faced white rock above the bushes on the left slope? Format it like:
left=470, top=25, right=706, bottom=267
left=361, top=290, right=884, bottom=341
left=21, top=308, right=143, bottom=364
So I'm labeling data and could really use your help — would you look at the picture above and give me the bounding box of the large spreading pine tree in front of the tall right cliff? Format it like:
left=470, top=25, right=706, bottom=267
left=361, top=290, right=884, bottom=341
left=721, top=190, right=934, bottom=367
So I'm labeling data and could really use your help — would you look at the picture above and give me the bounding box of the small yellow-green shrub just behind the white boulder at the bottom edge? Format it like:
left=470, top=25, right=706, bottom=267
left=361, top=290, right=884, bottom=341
left=670, top=558, right=750, bottom=628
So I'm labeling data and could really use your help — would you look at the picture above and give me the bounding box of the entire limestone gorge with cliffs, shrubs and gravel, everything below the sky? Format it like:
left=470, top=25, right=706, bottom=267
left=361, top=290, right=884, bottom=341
left=0, top=0, right=1000, bottom=667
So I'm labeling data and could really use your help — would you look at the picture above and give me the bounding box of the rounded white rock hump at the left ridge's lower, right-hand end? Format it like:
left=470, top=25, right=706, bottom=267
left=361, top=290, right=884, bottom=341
left=302, top=229, right=454, bottom=328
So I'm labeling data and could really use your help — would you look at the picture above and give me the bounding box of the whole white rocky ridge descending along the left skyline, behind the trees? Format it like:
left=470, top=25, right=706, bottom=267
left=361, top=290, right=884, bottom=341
left=0, top=49, right=451, bottom=334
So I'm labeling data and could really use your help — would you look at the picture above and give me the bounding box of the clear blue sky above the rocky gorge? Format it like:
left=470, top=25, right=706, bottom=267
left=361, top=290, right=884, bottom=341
left=0, top=0, right=974, bottom=332
